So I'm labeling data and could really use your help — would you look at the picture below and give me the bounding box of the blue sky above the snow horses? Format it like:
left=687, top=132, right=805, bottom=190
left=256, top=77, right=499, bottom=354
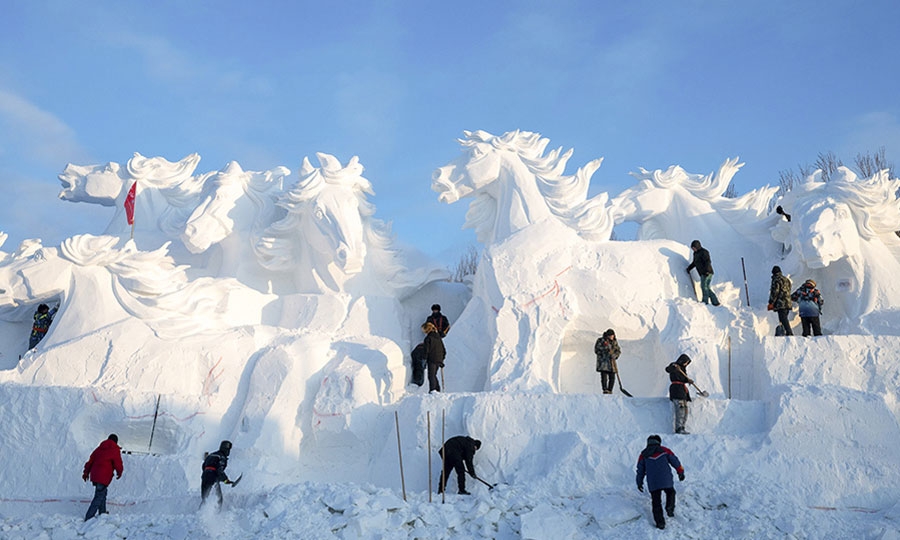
left=0, top=0, right=900, bottom=264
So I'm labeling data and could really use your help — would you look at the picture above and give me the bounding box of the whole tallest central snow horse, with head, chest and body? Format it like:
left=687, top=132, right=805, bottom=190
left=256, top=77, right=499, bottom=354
left=432, top=131, right=730, bottom=395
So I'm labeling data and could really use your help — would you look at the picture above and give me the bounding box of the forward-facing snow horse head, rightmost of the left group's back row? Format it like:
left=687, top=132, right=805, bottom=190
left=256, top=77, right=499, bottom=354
left=256, top=153, right=447, bottom=298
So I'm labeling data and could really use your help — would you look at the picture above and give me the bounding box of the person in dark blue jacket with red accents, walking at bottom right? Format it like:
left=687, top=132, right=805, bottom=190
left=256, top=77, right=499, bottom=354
left=635, top=435, right=684, bottom=529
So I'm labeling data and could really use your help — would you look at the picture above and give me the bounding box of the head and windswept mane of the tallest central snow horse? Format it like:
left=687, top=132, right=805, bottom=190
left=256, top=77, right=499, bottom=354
left=431, top=130, right=613, bottom=244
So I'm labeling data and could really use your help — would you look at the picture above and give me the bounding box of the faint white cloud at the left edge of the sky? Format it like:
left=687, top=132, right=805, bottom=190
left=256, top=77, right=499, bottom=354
left=0, top=88, right=87, bottom=169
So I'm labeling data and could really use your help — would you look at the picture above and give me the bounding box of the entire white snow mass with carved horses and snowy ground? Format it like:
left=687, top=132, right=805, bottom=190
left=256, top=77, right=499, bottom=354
left=0, top=132, right=900, bottom=538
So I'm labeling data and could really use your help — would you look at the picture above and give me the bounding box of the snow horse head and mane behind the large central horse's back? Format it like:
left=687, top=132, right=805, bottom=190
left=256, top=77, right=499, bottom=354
left=610, top=158, right=780, bottom=306
